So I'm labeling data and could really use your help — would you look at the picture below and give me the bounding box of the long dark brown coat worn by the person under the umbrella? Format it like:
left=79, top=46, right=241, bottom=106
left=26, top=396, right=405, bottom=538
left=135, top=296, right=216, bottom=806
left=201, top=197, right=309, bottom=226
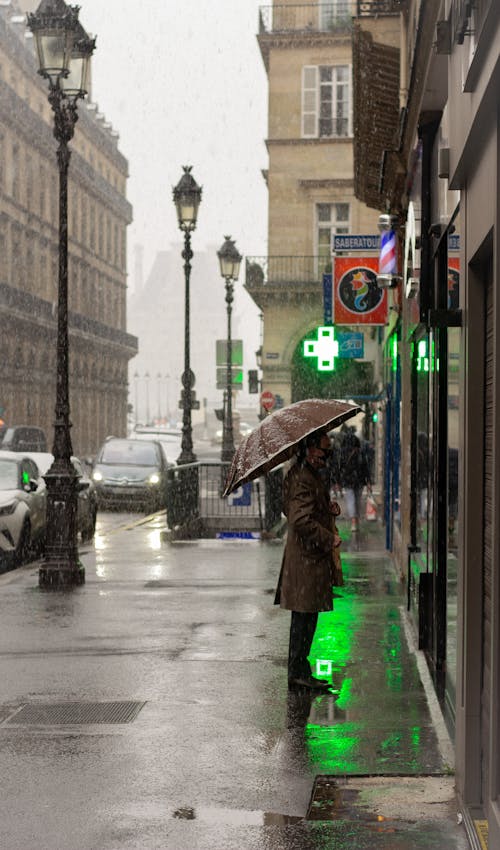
left=275, top=463, right=334, bottom=612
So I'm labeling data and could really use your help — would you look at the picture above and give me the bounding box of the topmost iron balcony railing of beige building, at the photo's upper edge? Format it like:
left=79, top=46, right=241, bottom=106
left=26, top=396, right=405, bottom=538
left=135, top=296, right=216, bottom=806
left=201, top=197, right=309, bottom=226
left=259, top=0, right=402, bottom=34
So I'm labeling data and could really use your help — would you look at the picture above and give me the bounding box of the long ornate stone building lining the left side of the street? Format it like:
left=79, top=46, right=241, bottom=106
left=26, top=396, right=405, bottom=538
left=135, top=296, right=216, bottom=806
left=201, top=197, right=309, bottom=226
left=0, top=2, right=137, bottom=454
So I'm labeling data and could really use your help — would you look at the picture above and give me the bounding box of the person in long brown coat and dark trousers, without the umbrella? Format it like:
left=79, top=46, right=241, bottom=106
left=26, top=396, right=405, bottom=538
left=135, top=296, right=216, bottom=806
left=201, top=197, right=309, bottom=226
left=275, top=432, right=341, bottom=690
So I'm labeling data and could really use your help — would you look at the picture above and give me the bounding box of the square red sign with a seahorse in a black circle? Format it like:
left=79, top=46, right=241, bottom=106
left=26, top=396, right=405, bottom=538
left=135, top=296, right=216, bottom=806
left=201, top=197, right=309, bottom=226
left=333, top=257, right=388, bottom=325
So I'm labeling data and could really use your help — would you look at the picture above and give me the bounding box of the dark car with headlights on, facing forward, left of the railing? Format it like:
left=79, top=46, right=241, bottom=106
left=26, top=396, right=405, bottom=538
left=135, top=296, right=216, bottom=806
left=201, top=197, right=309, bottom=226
left=92, top=437, right=171, bottom=512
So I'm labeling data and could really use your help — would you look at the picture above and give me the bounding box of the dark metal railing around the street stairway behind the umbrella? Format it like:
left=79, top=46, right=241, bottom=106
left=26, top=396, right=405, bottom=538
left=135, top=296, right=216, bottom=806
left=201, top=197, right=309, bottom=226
left=167, top=462, right=282, bottom=537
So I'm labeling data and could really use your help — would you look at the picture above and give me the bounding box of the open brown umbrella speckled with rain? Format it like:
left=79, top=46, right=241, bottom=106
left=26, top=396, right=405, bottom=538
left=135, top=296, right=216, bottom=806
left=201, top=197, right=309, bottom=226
left=222, top=398, right=360, bottom=496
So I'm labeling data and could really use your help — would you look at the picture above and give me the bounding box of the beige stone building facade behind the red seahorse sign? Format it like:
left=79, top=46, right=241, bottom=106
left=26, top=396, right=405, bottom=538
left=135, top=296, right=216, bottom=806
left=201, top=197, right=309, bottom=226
left=246, top=0, right=386, bottom=404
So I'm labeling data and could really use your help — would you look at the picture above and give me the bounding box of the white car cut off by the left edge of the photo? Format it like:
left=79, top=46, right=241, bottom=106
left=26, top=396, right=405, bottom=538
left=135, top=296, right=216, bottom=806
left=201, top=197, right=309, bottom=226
left=0, top=451, right=47, bottom=567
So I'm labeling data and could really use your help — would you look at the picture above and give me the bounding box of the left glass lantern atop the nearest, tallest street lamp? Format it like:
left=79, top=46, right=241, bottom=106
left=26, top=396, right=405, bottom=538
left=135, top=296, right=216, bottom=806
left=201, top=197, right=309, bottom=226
left=28, top=0, right=78, bottom=85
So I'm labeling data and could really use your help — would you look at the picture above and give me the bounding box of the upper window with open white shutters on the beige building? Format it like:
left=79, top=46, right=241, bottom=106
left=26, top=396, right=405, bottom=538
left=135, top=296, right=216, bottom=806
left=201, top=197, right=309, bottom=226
left=302, top=65, right=352, bottom=138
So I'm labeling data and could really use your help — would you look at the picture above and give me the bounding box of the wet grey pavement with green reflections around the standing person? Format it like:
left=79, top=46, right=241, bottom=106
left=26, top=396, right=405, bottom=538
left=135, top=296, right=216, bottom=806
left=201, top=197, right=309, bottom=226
left=0, top=516, right=468, bottom=850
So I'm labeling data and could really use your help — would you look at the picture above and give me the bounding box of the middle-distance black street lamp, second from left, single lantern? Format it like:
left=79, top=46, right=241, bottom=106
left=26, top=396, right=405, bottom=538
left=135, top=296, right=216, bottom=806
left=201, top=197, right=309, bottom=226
left=173, top=165, right=201, bottom=464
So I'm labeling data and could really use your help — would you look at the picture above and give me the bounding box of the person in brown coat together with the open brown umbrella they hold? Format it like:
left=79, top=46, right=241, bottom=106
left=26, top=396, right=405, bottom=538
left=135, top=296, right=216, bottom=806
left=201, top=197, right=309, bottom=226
left=222, top=398, right=360, bottom=690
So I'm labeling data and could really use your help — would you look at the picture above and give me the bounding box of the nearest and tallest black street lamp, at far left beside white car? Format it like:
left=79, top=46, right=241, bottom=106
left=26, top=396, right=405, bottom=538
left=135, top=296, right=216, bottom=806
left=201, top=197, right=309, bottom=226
left=27, top=0, right=95, bottom=590
